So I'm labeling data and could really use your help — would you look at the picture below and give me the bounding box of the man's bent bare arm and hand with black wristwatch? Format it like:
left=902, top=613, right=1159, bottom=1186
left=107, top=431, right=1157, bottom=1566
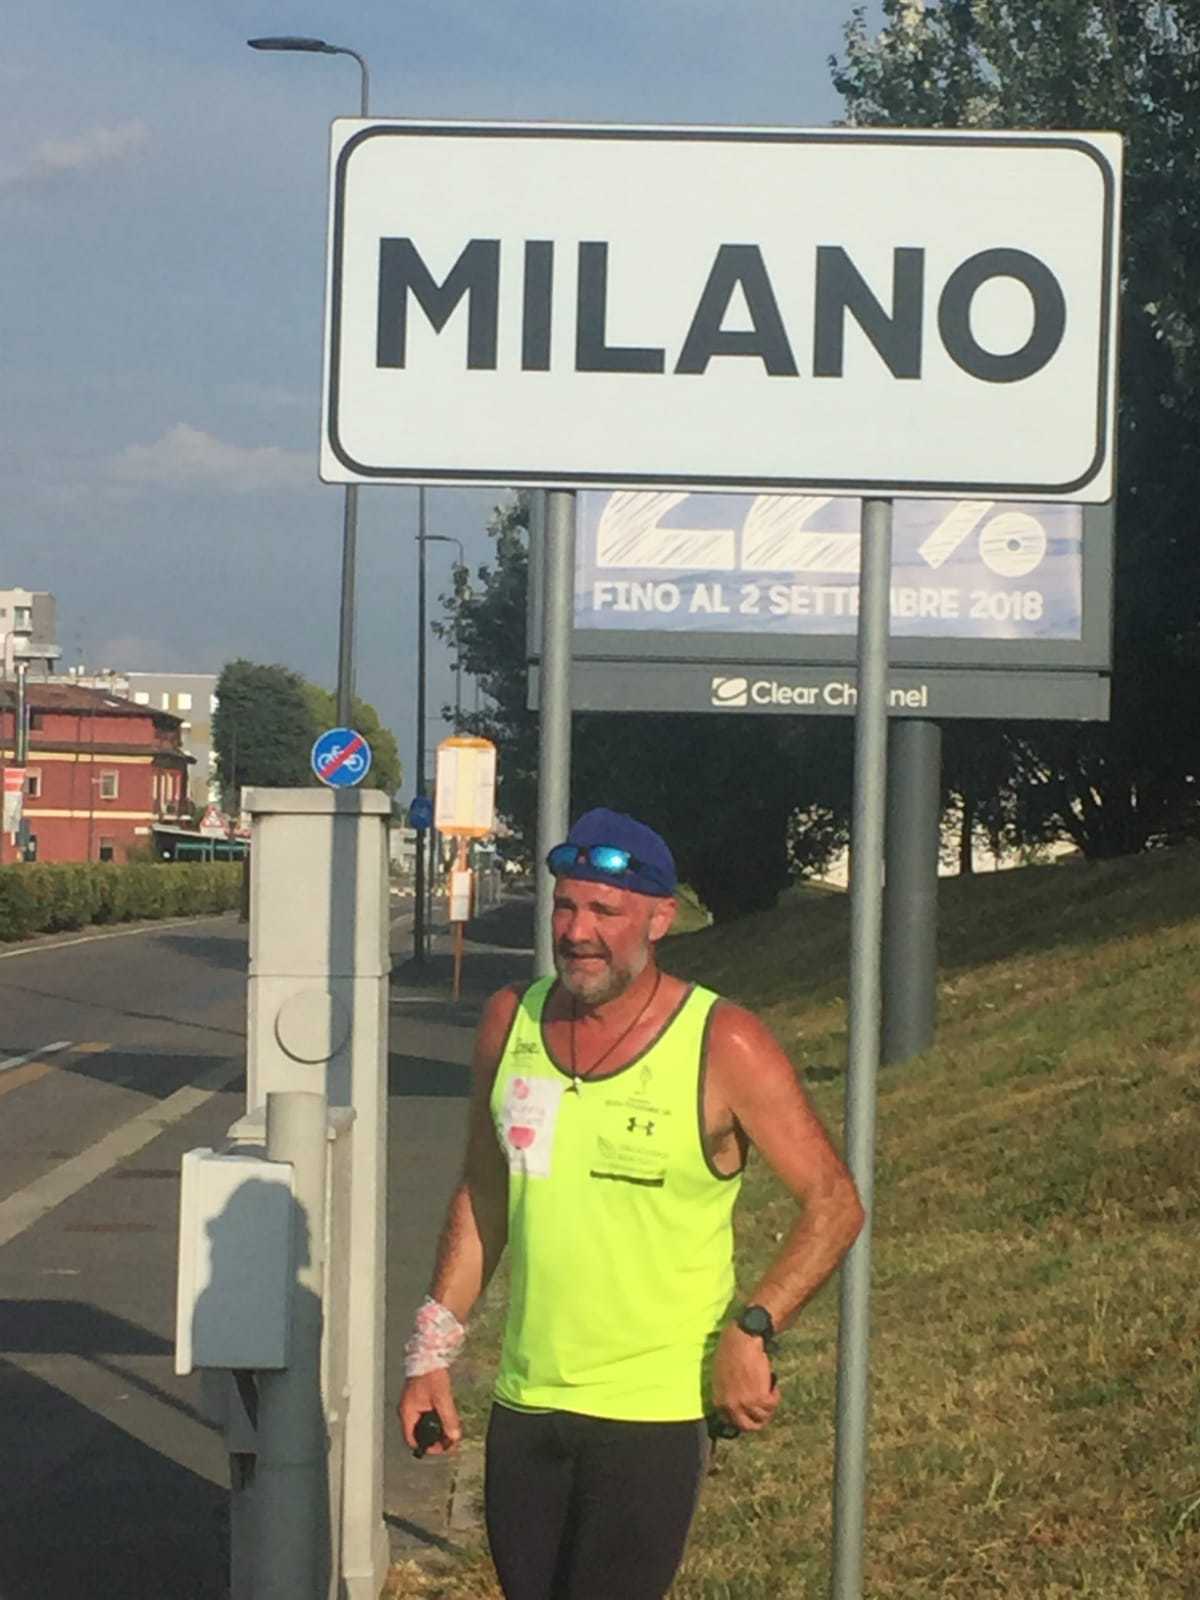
left=709, top=1005, right=866, bottom=1432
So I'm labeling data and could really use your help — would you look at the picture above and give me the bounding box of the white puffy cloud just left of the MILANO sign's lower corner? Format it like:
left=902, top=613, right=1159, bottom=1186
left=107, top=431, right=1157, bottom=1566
left=106, top=422, right=317, bottom=494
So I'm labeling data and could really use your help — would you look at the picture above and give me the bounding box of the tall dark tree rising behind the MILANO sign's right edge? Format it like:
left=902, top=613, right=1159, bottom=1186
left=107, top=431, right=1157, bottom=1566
left=830, top=0, right=1200, bottom=858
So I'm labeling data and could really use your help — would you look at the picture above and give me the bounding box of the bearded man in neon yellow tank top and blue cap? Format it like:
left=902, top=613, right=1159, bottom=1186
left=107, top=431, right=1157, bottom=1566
left=398, top=808, right=862, bottom=1600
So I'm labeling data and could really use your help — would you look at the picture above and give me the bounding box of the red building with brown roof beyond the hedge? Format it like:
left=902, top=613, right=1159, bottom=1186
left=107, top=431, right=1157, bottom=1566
left=0, top=680, right=190, bottom=861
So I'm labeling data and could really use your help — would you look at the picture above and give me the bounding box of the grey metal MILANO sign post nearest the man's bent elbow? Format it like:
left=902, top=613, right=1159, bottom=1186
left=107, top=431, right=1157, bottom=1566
left=832, top=499, right=891, bottom=1600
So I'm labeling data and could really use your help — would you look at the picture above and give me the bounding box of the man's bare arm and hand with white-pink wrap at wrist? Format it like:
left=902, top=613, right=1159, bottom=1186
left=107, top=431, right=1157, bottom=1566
left=397, top=989, right=520, bottom=1454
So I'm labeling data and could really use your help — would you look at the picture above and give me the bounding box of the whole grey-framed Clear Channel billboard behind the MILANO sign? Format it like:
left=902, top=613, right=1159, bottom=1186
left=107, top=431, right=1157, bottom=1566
left=528, top=491, right=1112, bottom=720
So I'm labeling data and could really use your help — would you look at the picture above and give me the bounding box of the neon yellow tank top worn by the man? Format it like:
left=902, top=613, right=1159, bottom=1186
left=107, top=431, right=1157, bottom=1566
left=491, top=978, right=741, bottom=1422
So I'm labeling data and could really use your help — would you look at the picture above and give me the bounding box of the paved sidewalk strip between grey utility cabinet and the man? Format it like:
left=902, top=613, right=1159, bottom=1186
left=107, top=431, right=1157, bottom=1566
left=384, top=896, right=533, bottom=1562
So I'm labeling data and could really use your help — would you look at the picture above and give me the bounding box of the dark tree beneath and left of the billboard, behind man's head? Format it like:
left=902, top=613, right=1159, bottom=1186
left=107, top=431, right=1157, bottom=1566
left=437, top=496, right=850, bottom=920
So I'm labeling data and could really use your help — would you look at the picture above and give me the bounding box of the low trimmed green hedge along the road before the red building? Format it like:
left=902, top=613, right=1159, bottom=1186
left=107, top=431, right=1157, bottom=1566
left=0, top=861, right=242, bottom=942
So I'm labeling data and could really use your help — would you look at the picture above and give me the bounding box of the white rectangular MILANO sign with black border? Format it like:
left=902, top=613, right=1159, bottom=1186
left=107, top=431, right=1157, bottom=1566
left=322, top=120, right=1122, bottom=501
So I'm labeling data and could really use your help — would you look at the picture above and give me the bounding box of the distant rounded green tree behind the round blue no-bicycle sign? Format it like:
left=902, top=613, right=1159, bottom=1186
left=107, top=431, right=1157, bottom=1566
left=213, top=659, right=400, bottom=808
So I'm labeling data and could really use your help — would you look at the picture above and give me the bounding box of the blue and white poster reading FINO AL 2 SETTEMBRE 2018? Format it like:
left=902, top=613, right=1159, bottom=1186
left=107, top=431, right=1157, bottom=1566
left=574, top=493, right=1083, bottom=640
